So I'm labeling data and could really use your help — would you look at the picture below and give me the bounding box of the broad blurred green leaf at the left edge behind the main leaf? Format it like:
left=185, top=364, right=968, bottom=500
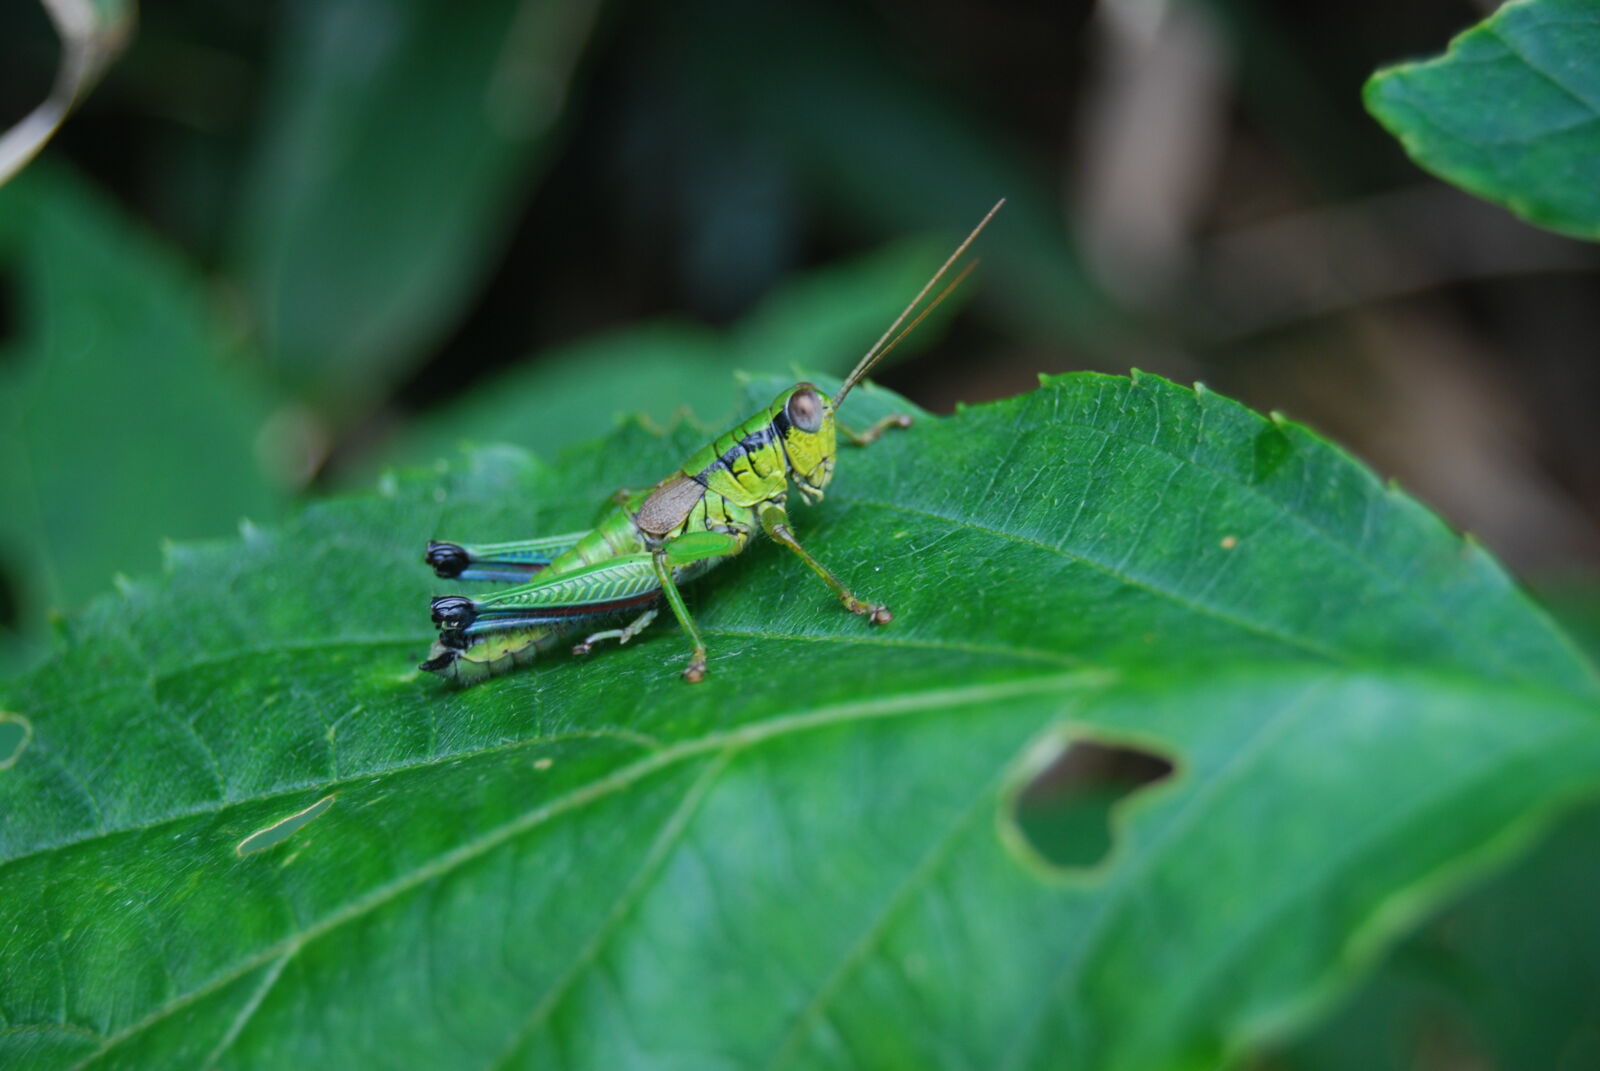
left=0, top=163, right=282, bottom=653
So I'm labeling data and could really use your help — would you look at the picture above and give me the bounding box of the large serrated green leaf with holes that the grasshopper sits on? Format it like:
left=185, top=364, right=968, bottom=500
left=0, top=375, right=1600, bottom=1069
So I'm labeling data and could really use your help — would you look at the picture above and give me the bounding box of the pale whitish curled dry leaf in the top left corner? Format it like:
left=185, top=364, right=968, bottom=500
left=0, top=0, right=134, bottom=186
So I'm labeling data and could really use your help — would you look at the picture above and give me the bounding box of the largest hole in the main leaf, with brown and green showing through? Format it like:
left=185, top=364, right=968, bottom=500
left=1014, top=740, right=1174, bottom=871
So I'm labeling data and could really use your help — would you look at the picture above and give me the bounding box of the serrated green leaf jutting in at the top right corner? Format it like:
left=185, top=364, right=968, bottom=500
left=1366, top=0, right=1600, bottom=239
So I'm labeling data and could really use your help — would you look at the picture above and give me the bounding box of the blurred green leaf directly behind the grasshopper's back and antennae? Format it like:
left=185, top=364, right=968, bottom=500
left=374, top=242, right=962, bottom=464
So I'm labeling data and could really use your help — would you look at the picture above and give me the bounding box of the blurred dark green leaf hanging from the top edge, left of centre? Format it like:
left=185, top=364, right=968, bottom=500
left=237, top=0, right=598, bottom=413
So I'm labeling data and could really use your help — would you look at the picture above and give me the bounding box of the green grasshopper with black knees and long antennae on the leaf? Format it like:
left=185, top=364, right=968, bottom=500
left=421, top=200, right=1005, bottom=685
